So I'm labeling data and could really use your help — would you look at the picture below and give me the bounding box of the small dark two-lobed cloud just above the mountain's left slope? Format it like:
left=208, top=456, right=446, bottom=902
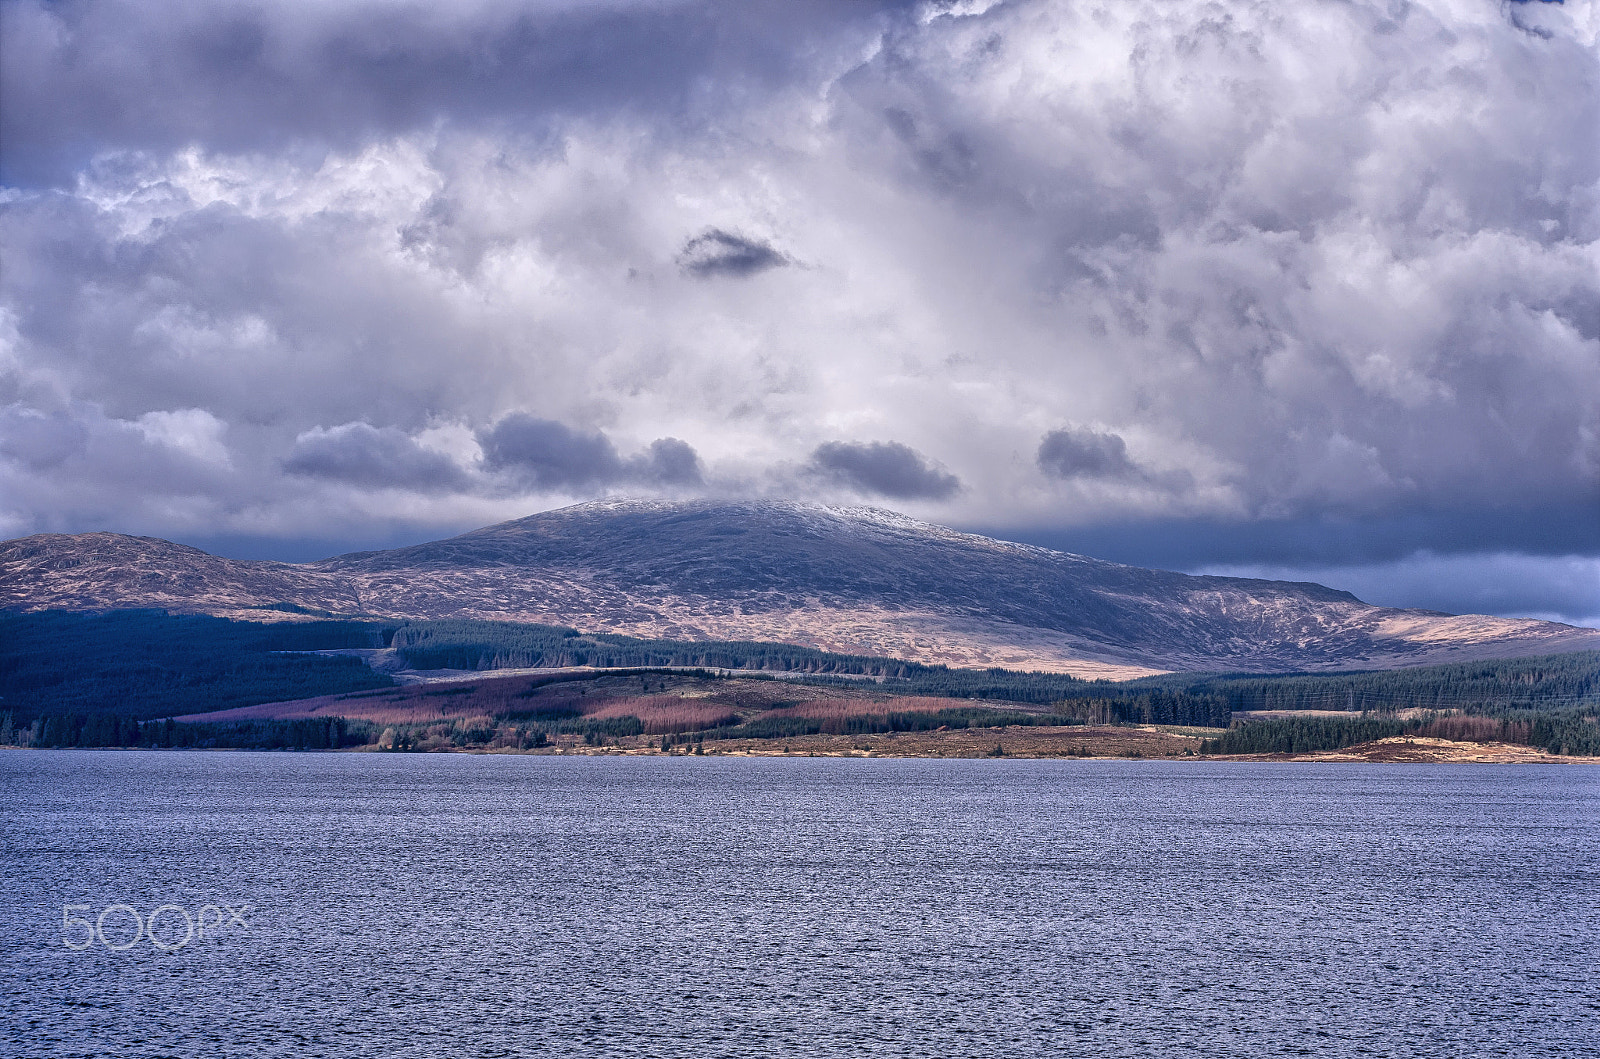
left=478, top=413, right=701, bottom=490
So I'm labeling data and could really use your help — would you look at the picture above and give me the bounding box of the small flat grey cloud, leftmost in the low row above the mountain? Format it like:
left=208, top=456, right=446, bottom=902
left=283, top=422, right=467, bottom=493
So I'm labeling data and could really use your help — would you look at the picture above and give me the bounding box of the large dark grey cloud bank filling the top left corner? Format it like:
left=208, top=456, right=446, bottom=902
left=0, top=0, right=910, bottom=182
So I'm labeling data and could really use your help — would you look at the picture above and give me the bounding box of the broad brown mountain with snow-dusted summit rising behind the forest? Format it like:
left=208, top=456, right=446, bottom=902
left=0, top=501, right=1600, bottom=677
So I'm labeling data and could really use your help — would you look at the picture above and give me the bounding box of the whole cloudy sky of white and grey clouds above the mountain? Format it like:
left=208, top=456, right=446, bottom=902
left=0, top=0, right=1600, bottom=624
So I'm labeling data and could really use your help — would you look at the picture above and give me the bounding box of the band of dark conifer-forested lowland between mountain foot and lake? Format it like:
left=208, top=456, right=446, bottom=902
left=0, top=609, right=1600, bottom=755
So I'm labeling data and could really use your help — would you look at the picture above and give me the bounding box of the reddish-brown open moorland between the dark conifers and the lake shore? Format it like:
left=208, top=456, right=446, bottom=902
left=168, top=670, right=1597, bottom=763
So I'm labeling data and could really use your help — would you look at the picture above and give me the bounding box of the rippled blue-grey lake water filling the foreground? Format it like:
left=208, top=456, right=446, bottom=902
left=0, top=750, right=1600, bottom=1057
